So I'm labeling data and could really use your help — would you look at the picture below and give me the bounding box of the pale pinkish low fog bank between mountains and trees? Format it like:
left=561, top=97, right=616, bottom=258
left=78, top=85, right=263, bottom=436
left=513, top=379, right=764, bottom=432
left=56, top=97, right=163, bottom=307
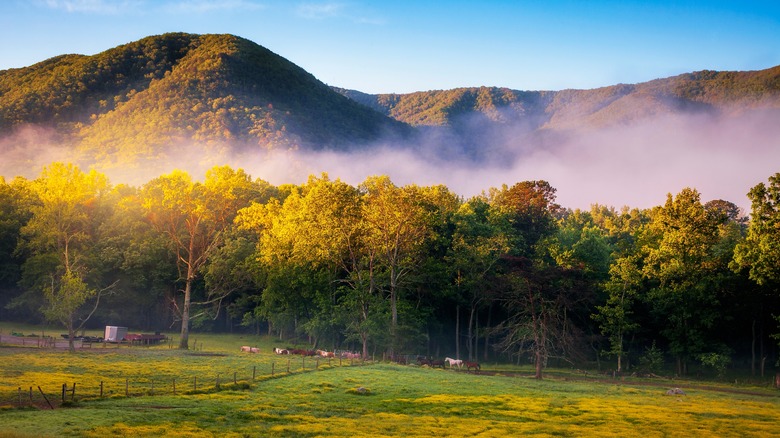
left=0, top=111, right=780, bottom=213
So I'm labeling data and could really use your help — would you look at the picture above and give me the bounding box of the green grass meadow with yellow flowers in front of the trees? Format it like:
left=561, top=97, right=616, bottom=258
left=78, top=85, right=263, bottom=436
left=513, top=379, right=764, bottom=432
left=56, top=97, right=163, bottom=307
left=0, top=324, right=780, bottom=437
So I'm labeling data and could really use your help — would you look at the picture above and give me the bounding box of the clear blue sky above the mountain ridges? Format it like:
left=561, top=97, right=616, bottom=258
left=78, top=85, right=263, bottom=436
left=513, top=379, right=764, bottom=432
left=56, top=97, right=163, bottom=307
left=0, top=0, right=780, bottom=93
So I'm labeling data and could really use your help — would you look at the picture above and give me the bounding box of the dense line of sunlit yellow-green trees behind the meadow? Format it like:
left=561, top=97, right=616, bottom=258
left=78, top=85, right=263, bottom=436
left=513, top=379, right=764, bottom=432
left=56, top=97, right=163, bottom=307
left=0, top=163, right=780, bottom=377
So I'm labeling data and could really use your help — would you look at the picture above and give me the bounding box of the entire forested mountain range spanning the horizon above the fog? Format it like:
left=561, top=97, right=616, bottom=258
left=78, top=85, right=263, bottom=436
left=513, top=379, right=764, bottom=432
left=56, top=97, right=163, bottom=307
left=0, top=33, right=780, bottom=166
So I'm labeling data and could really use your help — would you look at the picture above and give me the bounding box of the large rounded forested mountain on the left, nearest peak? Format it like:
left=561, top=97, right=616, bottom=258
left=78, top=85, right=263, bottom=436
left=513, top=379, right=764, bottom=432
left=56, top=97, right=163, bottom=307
left=0, top=33, right=408, bottom=161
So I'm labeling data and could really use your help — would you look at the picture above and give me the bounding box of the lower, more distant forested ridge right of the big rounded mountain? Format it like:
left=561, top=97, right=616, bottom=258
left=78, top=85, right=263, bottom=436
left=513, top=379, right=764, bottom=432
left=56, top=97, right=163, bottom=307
left=336, top=66, right=780, bottom=130
